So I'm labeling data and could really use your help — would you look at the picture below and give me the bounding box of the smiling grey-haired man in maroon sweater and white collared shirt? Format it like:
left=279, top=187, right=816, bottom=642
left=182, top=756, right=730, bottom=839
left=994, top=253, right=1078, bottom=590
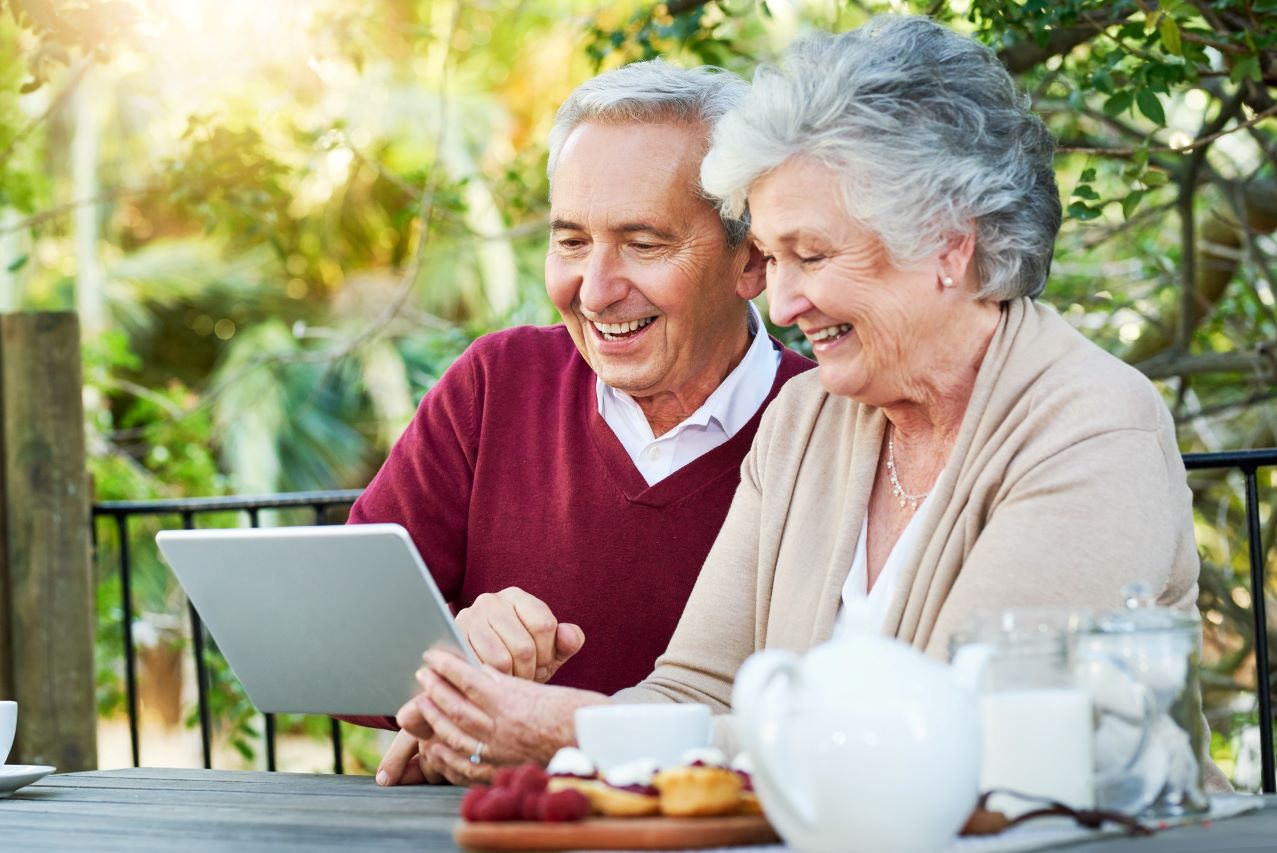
left=350, top=61, right=811, bottom=784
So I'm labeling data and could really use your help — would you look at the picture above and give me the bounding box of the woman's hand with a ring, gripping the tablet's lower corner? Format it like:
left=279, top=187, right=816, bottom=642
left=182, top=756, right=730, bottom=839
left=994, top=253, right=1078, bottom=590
left=396, top=649, right=608, bottom=785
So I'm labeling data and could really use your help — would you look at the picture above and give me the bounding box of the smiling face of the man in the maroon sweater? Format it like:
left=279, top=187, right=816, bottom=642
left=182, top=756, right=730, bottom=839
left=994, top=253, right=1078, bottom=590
left=545, top=117, right=753, bottom=405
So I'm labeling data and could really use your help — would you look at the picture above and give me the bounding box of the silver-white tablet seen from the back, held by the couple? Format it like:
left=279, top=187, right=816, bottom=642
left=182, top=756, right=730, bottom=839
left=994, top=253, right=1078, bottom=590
left=156, top=525, right=478, bottom=716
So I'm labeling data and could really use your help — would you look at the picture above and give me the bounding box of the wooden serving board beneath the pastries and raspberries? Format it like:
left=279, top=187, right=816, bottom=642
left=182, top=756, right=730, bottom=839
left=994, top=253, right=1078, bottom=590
left=452, top=815, right=780, bottom=850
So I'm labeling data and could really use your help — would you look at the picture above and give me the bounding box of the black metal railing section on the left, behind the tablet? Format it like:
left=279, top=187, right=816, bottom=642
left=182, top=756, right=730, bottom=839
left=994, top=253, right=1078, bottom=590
left=91, top=489, right=360, bottom=774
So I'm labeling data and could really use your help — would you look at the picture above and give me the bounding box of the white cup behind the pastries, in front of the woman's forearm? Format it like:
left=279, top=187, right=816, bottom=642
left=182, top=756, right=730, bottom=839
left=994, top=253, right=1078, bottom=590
left=576, top=704, right=713, bottom=773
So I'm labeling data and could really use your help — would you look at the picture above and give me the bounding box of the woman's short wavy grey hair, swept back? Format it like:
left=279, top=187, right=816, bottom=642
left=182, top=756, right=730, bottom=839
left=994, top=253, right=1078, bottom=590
left=701, top=15, right=1060, bottom=301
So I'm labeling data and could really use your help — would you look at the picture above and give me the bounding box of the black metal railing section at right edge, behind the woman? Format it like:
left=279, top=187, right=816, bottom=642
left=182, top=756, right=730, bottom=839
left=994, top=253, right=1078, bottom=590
left=1184, top=448, right=1277, bottom=794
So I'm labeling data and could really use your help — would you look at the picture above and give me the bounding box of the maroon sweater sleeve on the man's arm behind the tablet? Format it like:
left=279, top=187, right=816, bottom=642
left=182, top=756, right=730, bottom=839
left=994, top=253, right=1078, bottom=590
left=349, top=342, right=481, bottom=604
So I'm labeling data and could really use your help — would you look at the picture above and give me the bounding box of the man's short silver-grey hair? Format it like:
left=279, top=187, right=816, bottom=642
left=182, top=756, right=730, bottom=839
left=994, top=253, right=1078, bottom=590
left=545, top=59, right=750, bottom=249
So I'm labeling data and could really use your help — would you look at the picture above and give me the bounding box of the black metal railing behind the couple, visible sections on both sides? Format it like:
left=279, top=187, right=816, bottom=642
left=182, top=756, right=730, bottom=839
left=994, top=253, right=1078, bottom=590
left=93, top=448, right=1277, bottom=794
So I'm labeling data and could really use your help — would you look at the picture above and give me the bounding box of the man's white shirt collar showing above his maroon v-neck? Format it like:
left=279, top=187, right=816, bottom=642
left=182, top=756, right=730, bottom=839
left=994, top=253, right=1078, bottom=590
left=595, top=303, right=780, bottom=485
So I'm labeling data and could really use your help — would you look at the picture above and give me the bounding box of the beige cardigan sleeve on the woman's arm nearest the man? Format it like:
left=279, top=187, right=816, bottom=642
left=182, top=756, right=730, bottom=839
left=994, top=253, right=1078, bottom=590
left=614, top=421, right=770, bottom=713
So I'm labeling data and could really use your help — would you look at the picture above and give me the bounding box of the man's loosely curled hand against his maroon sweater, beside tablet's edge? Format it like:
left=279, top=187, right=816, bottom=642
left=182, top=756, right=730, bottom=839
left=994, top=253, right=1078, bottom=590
left=457, top=586, right=585, bottom=682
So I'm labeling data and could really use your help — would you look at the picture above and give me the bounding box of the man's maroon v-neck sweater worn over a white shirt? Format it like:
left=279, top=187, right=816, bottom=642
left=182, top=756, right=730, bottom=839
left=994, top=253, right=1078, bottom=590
left=350, top=326, right=813, bottom=693
